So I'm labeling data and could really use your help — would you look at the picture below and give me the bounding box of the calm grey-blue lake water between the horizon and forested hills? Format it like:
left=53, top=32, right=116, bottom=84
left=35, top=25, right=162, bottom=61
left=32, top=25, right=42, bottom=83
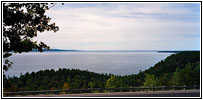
left=6, top=52, right=171, bottom=76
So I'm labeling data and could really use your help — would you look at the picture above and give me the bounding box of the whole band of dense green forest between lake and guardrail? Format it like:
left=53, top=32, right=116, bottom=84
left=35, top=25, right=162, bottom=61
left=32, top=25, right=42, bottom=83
left=3, top=51, right=200, bottom=92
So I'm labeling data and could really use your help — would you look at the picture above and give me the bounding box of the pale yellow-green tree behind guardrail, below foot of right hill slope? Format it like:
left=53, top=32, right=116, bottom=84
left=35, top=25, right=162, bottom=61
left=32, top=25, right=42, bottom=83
left=144, top=74, right=157, bottom=87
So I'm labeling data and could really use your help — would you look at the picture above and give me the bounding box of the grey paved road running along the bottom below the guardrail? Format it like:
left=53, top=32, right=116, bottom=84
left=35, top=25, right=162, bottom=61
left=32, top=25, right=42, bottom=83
left=18, top=90, right=200, bottom=97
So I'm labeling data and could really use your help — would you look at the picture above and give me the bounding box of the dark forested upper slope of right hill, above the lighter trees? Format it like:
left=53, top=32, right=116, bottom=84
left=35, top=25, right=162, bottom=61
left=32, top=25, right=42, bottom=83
left=144, top=51, right=200, bottom=77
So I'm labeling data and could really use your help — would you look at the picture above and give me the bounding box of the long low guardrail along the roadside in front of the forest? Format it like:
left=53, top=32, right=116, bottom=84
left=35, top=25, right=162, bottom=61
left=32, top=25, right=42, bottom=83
left=3, top=85, right=200, bottom=96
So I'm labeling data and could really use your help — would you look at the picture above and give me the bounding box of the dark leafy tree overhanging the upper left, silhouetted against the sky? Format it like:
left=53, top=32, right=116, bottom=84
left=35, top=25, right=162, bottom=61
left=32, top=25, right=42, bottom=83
left=3, top=3, right=59, bottom=71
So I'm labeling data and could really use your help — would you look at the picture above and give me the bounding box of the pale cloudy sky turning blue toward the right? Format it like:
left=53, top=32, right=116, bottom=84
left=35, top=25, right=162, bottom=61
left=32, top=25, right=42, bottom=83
left=34, top=2, right=200, bottom=50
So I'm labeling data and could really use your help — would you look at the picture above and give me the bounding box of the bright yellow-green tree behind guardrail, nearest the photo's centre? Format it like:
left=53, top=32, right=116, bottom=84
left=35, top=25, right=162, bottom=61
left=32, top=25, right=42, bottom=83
left=106, top=75, right=119, bottom=88
